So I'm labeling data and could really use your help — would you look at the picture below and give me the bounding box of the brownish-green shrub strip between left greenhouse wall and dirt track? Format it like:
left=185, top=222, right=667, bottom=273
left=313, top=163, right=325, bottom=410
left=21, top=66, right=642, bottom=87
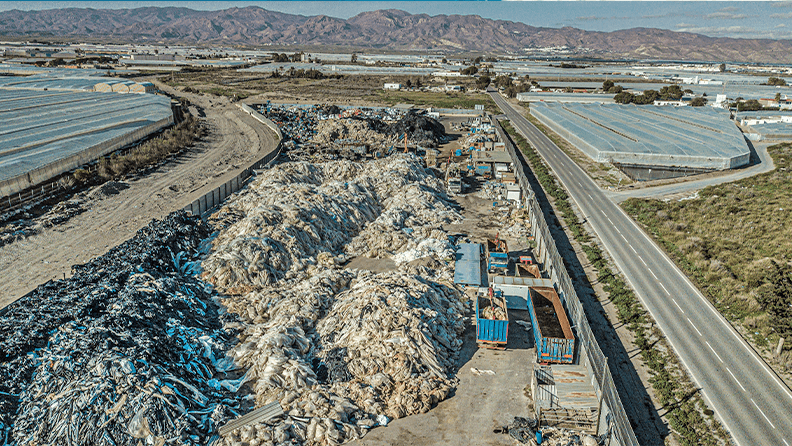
left=97, top=114, right=204, bottom=180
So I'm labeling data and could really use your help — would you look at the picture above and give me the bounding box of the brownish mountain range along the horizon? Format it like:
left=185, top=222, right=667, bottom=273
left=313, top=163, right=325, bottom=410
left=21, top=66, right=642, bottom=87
left=0, top=6, right=792, bottom=63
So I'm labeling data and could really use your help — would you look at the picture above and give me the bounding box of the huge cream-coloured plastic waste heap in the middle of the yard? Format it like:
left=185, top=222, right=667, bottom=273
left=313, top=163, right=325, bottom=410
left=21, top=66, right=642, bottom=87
left=203, top=155, right=464, bottom=446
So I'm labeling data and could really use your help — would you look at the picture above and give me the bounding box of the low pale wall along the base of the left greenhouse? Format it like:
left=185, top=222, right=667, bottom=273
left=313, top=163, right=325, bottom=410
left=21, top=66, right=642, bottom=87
left=0, top=115, right=173, bottom=197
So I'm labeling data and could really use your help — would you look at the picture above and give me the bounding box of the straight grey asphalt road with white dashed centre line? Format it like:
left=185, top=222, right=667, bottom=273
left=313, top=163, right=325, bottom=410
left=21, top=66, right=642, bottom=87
left=491, top=93, right=792, bottom=446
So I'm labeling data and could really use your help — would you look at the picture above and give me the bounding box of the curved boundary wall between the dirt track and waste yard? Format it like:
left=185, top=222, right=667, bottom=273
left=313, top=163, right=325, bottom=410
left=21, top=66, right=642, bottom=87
left=184, top=103, right=283, bottom=218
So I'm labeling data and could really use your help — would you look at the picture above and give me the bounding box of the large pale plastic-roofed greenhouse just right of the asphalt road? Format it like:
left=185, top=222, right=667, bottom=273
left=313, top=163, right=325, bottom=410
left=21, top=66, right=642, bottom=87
left=531, top=103, right=751, bottom=180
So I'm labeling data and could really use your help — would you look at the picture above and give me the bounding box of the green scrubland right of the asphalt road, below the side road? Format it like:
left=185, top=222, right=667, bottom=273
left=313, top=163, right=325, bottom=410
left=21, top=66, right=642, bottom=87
left=623, top=143, right=792, bottom=371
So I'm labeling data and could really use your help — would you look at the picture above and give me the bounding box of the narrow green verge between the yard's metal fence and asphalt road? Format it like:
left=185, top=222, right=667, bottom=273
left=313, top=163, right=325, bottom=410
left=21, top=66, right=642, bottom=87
left=502, top=122, right=732, bottom=446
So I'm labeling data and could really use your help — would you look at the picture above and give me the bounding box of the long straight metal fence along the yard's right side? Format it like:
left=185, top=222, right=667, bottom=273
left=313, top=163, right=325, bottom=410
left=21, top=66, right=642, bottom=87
left=495, top=124, right=640, bottom=446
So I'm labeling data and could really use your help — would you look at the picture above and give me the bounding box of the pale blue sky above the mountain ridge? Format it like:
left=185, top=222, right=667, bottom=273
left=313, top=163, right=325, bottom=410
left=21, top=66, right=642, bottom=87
left=0, top=0, right=792, bottom=39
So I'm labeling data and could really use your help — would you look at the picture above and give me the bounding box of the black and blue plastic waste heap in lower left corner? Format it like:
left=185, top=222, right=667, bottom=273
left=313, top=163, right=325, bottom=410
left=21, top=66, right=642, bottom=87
left=0, top=212, right=241, bottom=445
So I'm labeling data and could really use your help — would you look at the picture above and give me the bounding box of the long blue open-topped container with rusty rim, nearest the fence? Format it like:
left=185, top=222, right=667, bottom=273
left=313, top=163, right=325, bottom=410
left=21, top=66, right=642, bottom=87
left=527, top=287, right=575, bottom=364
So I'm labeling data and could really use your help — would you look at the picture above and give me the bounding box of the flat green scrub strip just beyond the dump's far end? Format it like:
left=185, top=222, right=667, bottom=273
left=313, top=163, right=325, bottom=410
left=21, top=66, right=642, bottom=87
left=365, top=90, right=499, bottom=113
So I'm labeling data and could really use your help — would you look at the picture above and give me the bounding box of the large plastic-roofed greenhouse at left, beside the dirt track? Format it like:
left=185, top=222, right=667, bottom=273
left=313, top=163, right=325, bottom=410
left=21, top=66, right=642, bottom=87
left=0, top=89, right=173, bottom=196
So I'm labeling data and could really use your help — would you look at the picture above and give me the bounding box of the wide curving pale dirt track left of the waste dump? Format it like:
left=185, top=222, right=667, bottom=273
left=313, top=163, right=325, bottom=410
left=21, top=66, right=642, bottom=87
left=0, top=83, right=277, bottom=308
